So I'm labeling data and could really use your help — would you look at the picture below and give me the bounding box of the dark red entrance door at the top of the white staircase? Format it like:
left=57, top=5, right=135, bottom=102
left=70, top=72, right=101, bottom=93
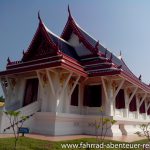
left=23, top=78, right=39, bottom=106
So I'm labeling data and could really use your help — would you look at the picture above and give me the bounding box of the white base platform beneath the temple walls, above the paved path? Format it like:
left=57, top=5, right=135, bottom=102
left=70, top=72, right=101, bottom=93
left=1, top=112, right=148, bottom=137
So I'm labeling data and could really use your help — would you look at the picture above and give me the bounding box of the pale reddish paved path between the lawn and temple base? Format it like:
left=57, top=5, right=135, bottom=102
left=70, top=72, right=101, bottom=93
left=0, top=134, right=145, bottom=142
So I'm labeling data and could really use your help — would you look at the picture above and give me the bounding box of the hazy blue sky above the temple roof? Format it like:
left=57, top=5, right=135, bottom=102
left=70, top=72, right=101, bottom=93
left=0, top=0, right=150, bottom=95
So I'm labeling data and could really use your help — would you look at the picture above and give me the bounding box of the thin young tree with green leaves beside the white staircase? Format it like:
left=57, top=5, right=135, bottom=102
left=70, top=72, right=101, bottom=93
left=4, top=110, right=29, bottom=150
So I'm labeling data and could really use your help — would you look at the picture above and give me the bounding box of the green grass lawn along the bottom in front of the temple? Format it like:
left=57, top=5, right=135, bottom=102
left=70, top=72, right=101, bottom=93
left=0, top=137, right=148, bottom=150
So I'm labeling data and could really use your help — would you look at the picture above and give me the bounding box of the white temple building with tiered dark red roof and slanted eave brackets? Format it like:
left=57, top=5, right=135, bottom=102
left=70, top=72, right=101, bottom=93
left=0, top=8, right=150, bottom=136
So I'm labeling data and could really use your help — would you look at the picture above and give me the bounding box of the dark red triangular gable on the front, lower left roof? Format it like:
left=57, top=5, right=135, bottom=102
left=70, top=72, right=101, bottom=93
left=22, top=22, right=58, bottom=62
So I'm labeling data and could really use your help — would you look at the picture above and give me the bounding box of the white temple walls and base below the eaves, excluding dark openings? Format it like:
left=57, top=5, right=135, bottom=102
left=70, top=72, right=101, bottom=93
left=1, top=73, right=150, bottom=136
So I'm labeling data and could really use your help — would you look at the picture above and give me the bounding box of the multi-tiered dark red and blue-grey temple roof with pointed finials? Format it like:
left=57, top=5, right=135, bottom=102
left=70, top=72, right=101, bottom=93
left=0, top=8, right=150, bottom=92
